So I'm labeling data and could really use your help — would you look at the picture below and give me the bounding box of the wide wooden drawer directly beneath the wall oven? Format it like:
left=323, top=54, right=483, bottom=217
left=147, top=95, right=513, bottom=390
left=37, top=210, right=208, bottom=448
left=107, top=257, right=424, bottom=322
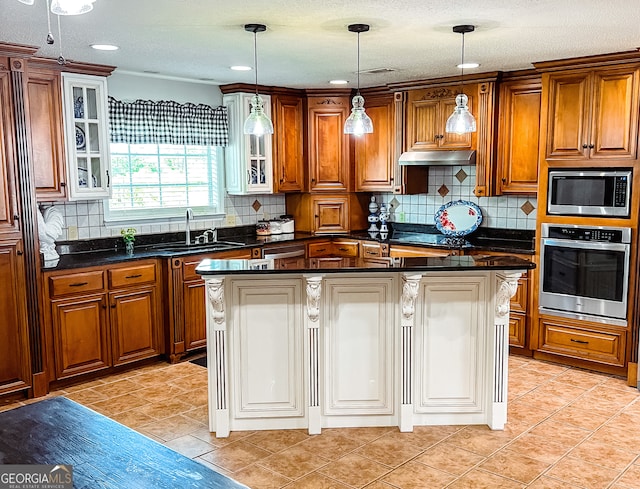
left=539, top=319, right=626, bottom=365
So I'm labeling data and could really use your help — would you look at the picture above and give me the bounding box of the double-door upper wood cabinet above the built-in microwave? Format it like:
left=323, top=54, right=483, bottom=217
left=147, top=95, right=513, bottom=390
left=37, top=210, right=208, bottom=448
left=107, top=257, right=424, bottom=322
left=543, top=64, right=640, bottom=160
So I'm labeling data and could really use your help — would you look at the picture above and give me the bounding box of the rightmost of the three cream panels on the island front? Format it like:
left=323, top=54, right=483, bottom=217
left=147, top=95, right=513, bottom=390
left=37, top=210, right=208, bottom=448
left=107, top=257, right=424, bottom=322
left=414, top=274, right=493, bottom=424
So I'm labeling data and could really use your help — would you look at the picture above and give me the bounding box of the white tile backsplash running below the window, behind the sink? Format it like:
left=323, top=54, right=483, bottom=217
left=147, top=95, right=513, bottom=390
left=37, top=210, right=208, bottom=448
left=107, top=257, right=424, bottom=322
left=48, top=194, right=285, bottom=241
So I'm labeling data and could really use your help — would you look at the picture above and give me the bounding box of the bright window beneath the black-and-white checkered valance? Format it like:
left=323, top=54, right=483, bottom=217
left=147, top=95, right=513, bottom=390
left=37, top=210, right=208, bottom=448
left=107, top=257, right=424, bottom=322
left=105, top=143, right=224, bottom=221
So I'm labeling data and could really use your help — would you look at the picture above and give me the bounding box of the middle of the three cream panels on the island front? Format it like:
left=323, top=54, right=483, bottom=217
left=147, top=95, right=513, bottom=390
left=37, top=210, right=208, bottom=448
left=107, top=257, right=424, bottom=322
left=322, top=275, right=398, bottom=427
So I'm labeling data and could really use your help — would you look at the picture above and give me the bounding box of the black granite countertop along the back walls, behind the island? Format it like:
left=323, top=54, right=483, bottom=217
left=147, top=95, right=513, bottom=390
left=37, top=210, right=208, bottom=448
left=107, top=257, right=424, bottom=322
left=43, top=223, right=534, bottom=271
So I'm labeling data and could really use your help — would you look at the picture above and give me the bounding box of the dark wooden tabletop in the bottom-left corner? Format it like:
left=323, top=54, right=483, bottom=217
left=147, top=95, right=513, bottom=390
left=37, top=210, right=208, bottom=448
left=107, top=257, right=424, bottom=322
left=0, top=397, right=246, bottom=489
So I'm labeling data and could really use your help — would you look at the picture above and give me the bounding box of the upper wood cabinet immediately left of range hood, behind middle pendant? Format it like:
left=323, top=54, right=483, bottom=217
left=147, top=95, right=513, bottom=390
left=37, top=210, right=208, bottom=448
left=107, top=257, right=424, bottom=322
left=351, top=94, right=397, bottom=192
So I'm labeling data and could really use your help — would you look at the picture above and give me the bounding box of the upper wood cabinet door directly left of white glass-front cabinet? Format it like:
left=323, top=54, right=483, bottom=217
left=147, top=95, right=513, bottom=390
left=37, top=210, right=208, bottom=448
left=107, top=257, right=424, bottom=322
left=27, top=67, right=67, bottom=202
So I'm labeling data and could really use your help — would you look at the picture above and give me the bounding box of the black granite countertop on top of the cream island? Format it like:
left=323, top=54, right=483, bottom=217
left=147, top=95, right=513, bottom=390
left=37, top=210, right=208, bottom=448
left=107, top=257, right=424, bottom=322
left=196, top=255, right=535, bottom=277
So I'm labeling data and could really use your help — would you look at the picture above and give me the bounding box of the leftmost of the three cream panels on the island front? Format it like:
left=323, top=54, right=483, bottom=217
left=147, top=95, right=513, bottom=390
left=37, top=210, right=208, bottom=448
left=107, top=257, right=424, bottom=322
left=230, top=279, right=305, bottom=418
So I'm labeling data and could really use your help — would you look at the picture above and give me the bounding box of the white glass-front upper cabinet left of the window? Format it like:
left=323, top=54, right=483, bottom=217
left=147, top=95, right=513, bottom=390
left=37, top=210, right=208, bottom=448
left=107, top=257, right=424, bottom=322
left=62, top=73, right=111, bottom=200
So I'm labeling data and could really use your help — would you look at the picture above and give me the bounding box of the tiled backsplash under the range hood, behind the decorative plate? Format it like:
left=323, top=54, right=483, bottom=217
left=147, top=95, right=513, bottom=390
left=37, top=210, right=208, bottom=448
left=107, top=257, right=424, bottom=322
left=376, top=165, right=538, bottom=230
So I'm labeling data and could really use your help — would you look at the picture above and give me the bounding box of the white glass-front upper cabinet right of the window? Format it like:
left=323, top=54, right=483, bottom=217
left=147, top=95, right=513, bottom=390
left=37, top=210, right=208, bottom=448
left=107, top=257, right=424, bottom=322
left=222, top=93, right=273, bottom=195
